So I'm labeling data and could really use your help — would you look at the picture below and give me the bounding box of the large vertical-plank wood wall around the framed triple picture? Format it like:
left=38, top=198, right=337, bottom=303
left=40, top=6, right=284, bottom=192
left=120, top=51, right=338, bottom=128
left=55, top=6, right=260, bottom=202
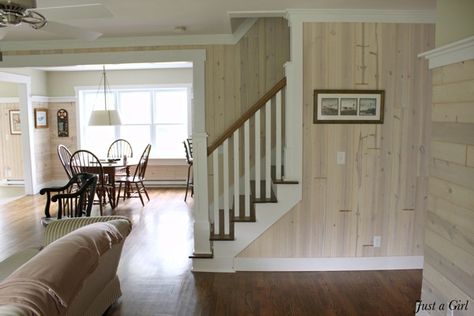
left=240, top=23, right=434, bottom=257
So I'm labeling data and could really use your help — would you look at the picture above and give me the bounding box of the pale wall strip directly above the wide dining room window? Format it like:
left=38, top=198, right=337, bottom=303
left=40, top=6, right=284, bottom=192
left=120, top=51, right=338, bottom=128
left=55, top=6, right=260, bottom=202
left=47, top=68, right=193, bottom=97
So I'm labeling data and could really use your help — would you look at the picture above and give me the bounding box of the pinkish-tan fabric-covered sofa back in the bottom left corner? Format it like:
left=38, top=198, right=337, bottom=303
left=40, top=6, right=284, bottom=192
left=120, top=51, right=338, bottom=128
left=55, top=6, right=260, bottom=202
left=0, top=222, right=124, bottom=315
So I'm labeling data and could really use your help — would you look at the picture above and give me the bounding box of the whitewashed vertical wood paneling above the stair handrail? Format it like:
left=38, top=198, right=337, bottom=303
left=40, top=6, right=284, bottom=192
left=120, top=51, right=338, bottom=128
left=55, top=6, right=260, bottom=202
left=206, top=18, right=289, bottom=144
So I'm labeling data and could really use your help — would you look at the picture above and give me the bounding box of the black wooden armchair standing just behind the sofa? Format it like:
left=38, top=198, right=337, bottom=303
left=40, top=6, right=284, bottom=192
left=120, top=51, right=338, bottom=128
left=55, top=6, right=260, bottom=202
left=40, top=173, right=97, bottom=225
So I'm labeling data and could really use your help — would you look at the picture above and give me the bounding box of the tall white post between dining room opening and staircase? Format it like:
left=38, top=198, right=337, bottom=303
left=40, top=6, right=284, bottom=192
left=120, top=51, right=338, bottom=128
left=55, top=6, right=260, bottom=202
left=192, top=55, right=212, bottom=257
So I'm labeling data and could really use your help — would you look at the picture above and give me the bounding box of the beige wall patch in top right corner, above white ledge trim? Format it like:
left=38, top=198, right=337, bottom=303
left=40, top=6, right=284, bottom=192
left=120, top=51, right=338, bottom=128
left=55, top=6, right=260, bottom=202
left=436, top=0, right=474, bottom=47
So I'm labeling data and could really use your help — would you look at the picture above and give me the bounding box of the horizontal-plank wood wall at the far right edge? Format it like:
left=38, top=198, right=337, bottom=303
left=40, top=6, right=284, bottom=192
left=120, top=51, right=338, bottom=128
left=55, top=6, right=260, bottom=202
left=422, top=60, right=474, bottom=315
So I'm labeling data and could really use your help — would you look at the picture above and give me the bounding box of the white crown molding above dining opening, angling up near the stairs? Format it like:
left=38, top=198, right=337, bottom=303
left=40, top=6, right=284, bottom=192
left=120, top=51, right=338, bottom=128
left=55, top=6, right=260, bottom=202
left=1, top=17, right=257, bottom=51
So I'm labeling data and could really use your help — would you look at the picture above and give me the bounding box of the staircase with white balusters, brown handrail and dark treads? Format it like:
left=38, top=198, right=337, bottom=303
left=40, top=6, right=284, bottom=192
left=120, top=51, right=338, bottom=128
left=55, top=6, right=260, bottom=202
left=192, top=78, right=299, bottom=272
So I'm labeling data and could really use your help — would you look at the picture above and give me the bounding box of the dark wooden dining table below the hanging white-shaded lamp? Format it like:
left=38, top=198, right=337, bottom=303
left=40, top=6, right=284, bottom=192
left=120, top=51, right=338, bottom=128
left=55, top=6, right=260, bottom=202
left=82, top=158, right=139, bottom=208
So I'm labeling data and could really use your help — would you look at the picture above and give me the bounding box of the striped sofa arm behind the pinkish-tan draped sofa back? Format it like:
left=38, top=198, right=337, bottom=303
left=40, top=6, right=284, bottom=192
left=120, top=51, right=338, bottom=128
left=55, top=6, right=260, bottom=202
left=43, top=216, right=130, bottom=246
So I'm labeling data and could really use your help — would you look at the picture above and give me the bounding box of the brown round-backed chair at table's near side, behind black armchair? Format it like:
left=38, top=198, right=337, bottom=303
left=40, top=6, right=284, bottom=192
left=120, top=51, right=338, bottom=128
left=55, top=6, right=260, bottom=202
left=69, top=150, right=115, bottom=216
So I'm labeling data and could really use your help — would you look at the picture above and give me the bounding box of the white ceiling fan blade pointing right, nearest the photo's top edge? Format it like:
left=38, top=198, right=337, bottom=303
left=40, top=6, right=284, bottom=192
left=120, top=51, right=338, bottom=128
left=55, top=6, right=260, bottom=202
left=35, top=3, right=114, bottom=21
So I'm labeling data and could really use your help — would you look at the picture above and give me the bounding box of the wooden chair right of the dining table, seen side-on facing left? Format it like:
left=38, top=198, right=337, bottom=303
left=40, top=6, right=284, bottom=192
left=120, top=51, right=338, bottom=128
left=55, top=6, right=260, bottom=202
left=115, top=144, right=151, bottom=206
